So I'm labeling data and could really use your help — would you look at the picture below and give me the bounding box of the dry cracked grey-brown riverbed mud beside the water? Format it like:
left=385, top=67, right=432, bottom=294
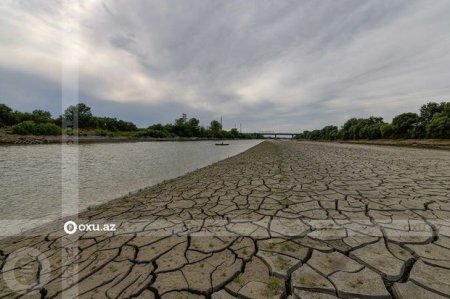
left=0, top=142, right=450, bottom=299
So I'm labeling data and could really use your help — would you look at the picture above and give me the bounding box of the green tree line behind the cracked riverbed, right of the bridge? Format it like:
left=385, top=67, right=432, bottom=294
left=296, top=102, right=450, bottom=140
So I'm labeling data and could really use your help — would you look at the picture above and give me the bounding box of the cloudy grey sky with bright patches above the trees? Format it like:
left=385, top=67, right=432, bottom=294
left=0, top=0, right=450, bottom=132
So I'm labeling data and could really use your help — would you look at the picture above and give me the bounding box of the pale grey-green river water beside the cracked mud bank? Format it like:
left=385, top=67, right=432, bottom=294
left=0, top=140, right=261, bottom=237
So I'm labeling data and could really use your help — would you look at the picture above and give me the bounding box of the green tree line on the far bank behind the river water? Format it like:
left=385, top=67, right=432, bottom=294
left=0, top=103, right=262, bottom=139
